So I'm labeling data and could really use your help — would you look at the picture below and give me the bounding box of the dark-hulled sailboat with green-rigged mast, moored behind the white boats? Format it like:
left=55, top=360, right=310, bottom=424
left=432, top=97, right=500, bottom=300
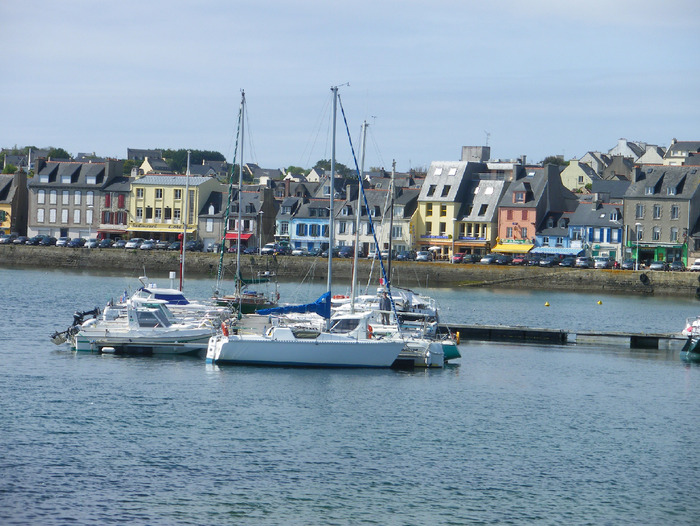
left=212, top=91, right=280, bottom=315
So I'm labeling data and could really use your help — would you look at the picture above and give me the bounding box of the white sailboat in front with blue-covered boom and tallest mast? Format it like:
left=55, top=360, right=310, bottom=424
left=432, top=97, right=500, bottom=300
left=206, top=87, right=404, bottom=367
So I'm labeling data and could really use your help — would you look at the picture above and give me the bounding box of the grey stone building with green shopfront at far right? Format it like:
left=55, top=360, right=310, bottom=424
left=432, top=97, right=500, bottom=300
left=624, top=166, right=700, bottom=264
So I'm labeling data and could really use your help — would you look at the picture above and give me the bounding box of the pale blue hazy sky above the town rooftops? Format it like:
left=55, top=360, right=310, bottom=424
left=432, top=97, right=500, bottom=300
left=0, top=0, right=700, bottom=171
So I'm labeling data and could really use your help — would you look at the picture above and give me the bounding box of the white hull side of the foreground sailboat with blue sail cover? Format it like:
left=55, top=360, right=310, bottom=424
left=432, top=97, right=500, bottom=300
left=207, top=335, right=403, bottom=368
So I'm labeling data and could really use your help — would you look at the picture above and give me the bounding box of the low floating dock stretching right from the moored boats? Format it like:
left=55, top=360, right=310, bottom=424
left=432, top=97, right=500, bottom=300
left=440, top=324, right=687, bottom=349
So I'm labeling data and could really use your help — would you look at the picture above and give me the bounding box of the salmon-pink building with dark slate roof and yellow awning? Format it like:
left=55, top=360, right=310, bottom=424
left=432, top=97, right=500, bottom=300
left=493, top=164, right=578, bottom=254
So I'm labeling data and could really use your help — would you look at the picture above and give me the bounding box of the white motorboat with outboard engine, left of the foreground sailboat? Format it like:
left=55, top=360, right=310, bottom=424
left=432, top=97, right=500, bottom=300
left=52, top=296, right=217, bottom=355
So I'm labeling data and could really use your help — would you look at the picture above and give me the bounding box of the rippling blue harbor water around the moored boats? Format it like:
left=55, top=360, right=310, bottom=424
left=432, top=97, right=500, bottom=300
left=0, top=269, right=700, bottom=525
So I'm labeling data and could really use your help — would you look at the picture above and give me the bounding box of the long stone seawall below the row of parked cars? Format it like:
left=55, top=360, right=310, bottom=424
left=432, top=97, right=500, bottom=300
left=0, top=245, right=700, bottom=296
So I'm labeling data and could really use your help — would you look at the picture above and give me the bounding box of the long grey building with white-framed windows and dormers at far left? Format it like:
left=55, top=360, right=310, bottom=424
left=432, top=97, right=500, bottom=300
left=27, top=158, right=123, bottom=238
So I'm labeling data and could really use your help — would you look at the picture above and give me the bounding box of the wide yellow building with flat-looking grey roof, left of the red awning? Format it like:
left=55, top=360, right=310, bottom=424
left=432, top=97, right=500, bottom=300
left=127, top=174, right=220, bottom=241
